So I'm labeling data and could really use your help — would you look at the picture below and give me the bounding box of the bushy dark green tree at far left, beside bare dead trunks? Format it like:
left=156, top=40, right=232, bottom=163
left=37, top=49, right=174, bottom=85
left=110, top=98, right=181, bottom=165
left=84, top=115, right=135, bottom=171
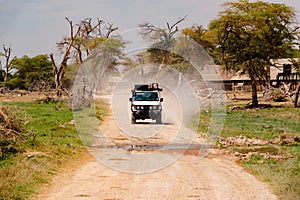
left=7, top=55, right=54, bottom=91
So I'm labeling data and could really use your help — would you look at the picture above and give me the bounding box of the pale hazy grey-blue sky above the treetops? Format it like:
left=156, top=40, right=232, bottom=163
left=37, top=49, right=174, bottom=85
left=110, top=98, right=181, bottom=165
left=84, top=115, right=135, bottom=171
left=0, top=0, right=300, bottom=57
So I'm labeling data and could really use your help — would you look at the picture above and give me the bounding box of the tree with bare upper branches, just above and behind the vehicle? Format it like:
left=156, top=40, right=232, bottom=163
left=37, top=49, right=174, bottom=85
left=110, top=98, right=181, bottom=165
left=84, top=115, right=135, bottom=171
left=138, top=16, right=207, bottom=87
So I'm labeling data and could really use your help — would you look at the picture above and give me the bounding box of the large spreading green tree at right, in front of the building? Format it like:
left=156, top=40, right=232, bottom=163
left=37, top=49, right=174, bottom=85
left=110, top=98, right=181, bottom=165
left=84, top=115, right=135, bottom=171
left=209, top=0, right=298, bottom=106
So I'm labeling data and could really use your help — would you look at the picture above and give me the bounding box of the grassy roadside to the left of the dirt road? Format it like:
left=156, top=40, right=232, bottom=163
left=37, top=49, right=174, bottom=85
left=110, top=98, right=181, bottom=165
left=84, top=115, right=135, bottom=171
left=0, top=101, right=104, bottom=199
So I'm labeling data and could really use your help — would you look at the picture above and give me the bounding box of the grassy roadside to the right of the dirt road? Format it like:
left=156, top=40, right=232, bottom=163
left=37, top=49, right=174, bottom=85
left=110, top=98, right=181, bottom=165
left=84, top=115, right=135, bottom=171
left=199, top=102, right=300, bottom=200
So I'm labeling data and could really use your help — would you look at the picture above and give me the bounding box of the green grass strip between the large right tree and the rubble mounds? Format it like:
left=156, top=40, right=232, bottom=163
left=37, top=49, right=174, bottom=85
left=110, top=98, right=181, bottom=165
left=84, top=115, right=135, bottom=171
left=199, top=107, right=300, bottom=139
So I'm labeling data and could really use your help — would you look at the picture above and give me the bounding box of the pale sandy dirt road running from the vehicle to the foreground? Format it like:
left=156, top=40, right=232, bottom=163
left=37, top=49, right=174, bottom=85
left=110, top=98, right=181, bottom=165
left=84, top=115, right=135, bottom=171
left=37, top=108, right=277, bottom=200
